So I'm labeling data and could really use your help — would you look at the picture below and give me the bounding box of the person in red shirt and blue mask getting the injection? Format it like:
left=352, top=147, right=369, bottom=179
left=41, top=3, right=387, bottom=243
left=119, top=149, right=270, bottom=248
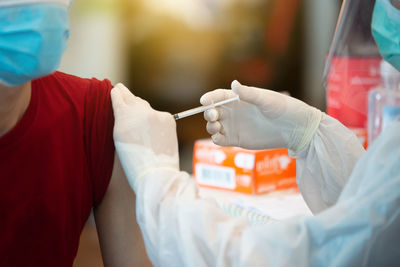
left=0, top=0, right=150, bottom=266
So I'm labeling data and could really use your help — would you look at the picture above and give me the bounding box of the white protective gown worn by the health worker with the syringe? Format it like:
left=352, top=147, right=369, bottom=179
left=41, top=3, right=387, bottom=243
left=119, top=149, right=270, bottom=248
left=137, top=114, right=400, bottom=267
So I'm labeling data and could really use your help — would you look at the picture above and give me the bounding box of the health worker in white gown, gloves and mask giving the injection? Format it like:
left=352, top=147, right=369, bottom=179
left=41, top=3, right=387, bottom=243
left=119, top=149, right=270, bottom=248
left=111, top=0, right=400, bottom=266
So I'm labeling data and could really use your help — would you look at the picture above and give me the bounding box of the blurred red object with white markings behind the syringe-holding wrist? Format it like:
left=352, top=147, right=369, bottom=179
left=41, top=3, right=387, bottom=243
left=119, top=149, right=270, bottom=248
left=327, top=56, right=381, bottom=128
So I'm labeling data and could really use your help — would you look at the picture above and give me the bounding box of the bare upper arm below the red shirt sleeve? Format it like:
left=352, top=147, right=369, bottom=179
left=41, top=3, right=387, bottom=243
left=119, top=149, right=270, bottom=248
left=94, top=154, right=151, bottom=267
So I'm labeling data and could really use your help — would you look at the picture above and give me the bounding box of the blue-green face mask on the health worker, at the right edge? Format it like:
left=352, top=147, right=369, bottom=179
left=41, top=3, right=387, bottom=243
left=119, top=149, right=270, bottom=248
left=372, top=0, right=400, bottom=70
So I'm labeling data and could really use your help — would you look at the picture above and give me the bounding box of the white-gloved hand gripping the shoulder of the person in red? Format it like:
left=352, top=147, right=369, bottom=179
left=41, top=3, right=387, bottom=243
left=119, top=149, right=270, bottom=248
left=111, top=83, right=179, bottom=192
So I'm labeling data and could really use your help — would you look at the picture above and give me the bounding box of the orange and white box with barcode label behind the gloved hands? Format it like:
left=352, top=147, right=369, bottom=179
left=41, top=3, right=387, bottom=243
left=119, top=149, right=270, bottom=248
left=193, top=139, right=297, bottom=194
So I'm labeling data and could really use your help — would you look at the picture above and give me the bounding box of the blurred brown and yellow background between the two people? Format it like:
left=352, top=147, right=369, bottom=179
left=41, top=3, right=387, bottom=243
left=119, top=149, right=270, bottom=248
left=60, top=0, right=341, bottom=266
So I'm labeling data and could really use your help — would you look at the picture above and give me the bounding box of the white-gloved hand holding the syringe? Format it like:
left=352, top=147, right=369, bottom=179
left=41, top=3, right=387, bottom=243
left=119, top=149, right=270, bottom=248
left=200, top=81, right=322, bottom=152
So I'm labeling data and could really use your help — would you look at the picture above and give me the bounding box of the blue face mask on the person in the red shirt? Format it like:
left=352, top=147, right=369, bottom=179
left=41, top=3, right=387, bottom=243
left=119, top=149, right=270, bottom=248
left=0, top=3, right=69, bottom=86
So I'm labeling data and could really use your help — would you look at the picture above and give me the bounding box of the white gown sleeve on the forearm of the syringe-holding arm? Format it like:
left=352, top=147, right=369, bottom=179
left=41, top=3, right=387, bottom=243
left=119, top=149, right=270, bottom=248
left=296, top=114, right=365, bottom=213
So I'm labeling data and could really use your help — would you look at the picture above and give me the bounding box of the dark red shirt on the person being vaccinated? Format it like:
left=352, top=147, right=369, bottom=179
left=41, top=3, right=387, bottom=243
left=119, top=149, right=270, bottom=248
left=0, top=72, right=114, bottom=266
